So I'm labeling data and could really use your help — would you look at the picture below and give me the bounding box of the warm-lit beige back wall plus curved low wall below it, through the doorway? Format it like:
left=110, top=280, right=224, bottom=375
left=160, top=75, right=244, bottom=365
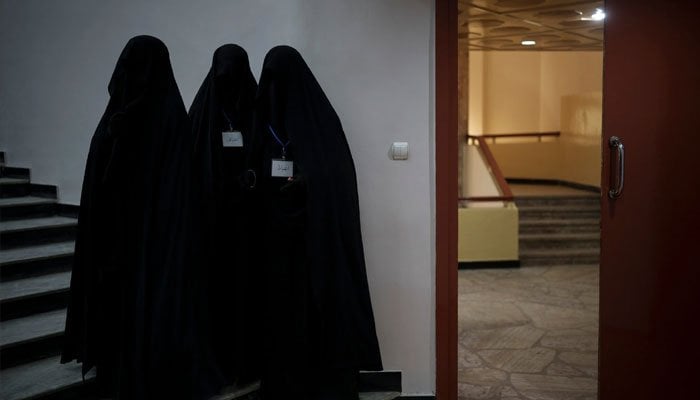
left=468, top=51, right=603, bottom=186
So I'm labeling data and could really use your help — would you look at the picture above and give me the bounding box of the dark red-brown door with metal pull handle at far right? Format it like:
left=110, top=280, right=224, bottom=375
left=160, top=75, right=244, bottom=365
left=599, top=0, right=700, bottom=400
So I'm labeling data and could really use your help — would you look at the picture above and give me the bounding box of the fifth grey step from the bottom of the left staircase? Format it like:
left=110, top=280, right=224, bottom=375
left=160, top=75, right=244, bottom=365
left=0, top=216, right=78, bottom=250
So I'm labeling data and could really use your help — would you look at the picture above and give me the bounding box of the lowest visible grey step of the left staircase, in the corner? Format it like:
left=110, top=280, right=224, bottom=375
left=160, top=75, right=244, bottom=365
left=0, top=357, right=94, bottom=400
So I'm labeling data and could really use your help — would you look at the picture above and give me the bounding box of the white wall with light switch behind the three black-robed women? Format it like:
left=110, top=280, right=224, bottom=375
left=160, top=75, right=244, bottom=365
left=0, top=0, right=435, bottom=394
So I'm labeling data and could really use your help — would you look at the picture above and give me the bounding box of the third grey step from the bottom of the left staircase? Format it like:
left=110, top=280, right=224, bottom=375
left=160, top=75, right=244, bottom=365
left=0, top=272, right=71, bottom=321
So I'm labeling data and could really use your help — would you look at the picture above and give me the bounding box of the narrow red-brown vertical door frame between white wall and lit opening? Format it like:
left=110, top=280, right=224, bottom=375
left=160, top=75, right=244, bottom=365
left=435, top=0, right=458, bottom=400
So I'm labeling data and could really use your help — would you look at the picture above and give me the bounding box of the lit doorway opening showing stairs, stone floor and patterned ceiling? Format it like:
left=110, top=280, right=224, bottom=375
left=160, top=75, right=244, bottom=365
left=457, top=0, right=604, bottom=400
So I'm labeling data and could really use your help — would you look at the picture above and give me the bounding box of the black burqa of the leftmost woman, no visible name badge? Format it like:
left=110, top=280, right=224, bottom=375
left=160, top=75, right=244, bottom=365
left=61, top=36, right=221, bottom=399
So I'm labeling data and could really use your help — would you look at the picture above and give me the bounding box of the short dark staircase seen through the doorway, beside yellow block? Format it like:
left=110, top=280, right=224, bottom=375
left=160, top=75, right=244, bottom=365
left=515, top=192, right=600, bottom=266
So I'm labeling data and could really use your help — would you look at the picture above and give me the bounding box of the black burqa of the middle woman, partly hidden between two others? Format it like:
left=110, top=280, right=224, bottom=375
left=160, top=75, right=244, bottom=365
left=189, top=44, right=260, bottom=384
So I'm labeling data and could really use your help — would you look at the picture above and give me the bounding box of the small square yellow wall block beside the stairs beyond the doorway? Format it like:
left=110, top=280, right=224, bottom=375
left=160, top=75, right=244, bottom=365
left=457, top=203, right=518, bottom=262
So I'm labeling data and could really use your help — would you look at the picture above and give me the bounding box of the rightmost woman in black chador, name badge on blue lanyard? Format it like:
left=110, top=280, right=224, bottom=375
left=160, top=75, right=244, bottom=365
left=250, top=46, right=382, bottom=400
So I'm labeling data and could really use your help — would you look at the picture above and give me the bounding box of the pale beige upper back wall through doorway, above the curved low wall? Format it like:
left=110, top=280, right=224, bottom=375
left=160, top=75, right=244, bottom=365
left=468, top=51, right=603, bottom=135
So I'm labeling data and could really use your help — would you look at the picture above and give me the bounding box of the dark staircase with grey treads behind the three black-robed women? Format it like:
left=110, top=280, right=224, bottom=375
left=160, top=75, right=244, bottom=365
left=0, top=152, right=401, bottom=400
